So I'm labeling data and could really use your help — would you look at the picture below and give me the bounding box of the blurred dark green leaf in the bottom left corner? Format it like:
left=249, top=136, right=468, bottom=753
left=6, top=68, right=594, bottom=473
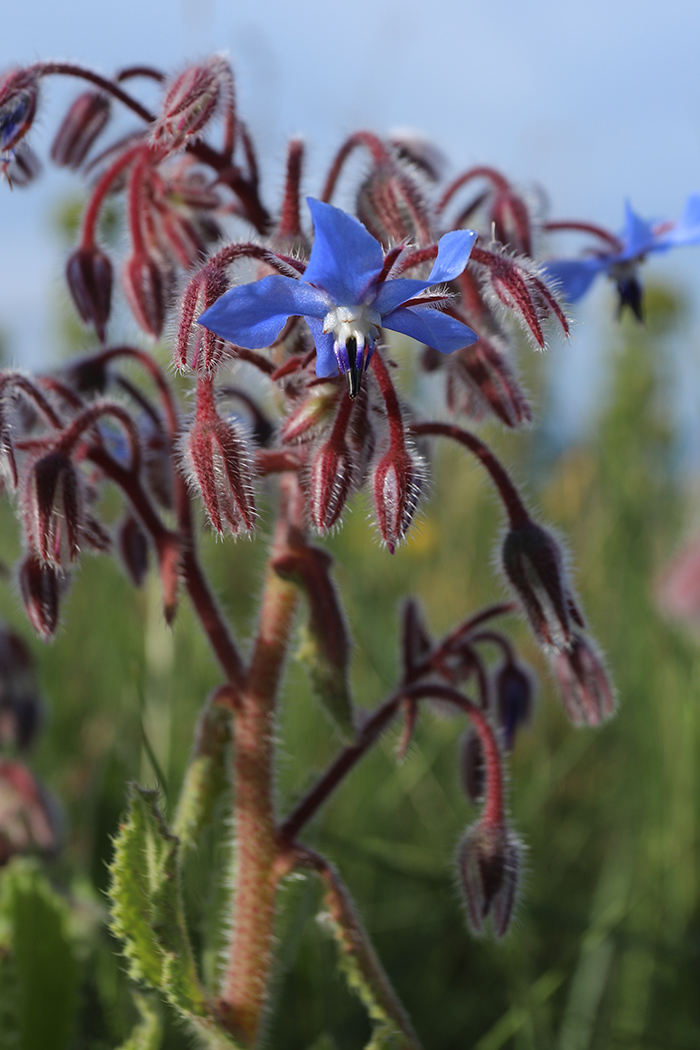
left=0, top=860, right=80, bottom=1050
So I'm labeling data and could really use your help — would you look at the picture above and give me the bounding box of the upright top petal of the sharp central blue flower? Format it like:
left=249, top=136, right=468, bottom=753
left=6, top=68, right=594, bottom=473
left=304, top=197, right=384, bottom=307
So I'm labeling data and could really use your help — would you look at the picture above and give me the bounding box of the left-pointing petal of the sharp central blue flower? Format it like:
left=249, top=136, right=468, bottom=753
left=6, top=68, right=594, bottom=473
left=198, top=274, right=330, bottom=350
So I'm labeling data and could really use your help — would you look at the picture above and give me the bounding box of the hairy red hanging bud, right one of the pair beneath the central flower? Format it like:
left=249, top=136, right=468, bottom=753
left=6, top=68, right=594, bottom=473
left=372, top=444, right=425, bottom=554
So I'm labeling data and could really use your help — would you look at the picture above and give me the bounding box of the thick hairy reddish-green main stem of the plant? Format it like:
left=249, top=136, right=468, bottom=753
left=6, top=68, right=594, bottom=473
left=220, top=478, right=298, bottom=1046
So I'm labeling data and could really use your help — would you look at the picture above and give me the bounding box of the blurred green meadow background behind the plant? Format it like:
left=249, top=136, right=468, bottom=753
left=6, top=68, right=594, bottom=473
left=0, top=289, right=700, bottom=1050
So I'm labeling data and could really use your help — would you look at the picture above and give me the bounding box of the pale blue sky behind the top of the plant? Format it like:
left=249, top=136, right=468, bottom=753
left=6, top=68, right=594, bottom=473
left=0, top=0, right=700, bottom=440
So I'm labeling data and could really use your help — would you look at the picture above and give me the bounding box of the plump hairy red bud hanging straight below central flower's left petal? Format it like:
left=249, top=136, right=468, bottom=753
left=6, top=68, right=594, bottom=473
left=184, top=412, right=257, bottom=536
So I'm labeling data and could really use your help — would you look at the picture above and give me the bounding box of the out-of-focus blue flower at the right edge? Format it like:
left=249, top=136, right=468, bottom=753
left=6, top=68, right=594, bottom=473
left=546, top=193, right=700, bottom=317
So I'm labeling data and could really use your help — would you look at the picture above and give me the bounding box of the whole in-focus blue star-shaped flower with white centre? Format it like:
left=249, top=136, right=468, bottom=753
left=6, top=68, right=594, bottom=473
left=199, top=197, right=476, bottom=398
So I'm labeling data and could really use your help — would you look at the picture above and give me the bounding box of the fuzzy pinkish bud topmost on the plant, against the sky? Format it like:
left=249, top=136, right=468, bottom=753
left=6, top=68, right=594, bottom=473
left=153, top=57, right=233, bottom=149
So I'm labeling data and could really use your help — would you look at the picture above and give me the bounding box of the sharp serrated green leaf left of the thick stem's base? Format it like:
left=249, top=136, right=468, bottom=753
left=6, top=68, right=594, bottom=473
left=109, top=788, right=207, bottom=1016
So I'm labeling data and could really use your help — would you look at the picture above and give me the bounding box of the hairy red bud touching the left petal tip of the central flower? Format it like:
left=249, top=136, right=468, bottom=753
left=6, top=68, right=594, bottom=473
left=174, top=264, right=229, bottom=376
